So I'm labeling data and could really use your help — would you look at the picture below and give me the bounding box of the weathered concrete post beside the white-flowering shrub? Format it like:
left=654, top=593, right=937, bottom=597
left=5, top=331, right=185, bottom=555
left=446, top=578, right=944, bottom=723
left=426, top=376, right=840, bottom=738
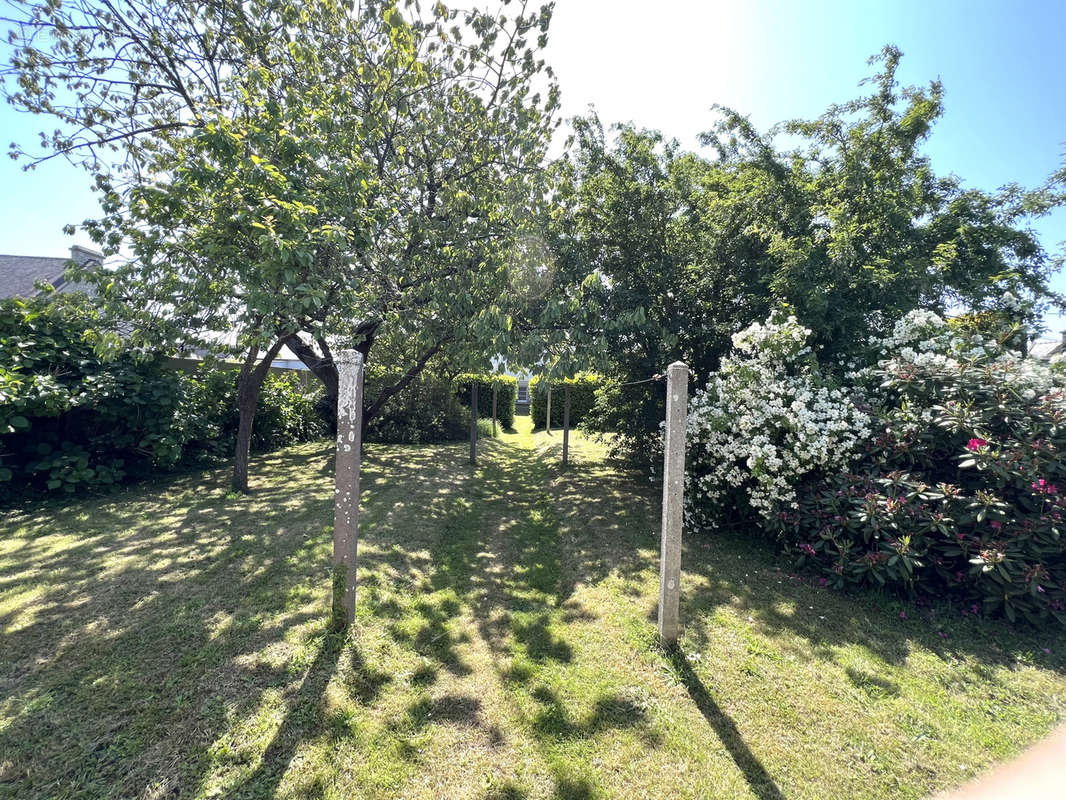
left=659, top=362, right=689, bottom=645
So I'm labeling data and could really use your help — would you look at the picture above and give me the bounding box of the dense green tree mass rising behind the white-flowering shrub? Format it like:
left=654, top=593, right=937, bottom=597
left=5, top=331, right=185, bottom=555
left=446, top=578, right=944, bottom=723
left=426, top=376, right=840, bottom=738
left=553, top=47, right=1063, bottom=455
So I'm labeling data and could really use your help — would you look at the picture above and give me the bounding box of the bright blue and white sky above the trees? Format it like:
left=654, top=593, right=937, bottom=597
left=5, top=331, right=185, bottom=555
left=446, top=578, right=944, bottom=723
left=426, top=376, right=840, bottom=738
left=0, top=0, right=1066, bottom=332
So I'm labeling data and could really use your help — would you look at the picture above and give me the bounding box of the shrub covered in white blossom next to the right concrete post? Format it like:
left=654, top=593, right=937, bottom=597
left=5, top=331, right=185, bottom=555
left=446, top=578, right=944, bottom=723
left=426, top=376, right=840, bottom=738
left=688, top=317, right=870, bottom=518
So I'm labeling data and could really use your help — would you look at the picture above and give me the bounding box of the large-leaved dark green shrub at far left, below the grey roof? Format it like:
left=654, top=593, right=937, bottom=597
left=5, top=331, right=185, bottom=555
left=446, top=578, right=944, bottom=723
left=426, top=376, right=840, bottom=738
left=0, top=295, right=183, bottom=493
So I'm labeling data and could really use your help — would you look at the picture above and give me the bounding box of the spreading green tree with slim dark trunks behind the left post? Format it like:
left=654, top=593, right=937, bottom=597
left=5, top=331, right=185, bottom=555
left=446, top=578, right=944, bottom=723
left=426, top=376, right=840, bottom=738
left=9, top=0, right=558, bottom=491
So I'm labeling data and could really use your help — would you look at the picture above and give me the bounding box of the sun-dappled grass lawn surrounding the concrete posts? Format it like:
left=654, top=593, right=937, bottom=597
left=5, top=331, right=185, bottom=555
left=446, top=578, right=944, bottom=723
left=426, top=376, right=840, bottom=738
left=0, top=417, right=1066, bottom=800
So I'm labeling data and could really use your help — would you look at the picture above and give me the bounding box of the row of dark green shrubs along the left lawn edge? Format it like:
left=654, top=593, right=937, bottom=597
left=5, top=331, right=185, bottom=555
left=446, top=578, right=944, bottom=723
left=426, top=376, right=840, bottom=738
left=0, top=295, right=324, bottom=494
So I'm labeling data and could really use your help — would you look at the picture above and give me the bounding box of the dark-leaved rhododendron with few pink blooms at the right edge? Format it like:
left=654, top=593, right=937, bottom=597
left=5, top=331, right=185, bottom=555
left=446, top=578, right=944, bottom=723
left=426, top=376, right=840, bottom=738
left=769, top=345, right=1066, bottom=623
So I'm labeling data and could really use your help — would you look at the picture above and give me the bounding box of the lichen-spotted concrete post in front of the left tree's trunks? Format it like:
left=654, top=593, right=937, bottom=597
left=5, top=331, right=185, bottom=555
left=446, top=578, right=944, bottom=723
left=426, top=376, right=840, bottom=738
left=333, top=350, right=362, bottom=629
